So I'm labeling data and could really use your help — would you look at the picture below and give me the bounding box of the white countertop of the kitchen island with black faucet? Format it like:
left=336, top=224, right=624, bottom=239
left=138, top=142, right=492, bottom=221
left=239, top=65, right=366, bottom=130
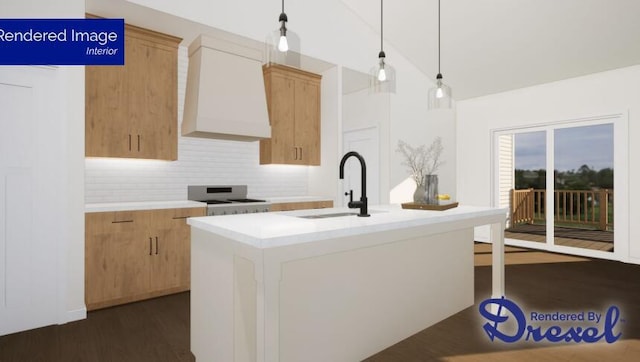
left=187, top=205, right=507, bottom=249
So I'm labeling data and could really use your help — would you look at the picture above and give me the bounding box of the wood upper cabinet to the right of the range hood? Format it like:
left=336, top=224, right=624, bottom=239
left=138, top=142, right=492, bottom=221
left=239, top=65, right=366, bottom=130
left=260, top=64, right=322, bottom=166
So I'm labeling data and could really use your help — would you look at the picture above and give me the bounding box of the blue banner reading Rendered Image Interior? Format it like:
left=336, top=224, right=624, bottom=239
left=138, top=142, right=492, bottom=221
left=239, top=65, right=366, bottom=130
left=0, top=19, right=124, bottom=65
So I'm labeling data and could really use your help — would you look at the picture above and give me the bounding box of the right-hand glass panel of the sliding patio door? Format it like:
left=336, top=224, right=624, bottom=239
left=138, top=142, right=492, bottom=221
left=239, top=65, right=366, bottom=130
left=553, top=123, right=614, bottom=252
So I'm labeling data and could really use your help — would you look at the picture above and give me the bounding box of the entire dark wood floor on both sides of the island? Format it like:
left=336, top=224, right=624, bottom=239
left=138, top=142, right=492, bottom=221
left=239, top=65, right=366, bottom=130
left=0, top=260, right=640, bottom=362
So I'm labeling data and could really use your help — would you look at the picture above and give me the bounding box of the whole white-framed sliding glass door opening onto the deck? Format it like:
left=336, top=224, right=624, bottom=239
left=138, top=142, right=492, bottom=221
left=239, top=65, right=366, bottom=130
left=493, top=114, right=615, bottom=257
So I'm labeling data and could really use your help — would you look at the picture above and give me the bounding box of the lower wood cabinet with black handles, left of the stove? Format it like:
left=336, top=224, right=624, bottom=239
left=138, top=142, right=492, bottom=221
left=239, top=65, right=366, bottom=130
left=85, top=208, right=206, bottom=310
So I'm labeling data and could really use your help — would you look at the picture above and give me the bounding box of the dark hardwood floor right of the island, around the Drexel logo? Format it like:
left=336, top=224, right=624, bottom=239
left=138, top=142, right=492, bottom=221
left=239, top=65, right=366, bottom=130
left=366, top=260, right=640, bottom=362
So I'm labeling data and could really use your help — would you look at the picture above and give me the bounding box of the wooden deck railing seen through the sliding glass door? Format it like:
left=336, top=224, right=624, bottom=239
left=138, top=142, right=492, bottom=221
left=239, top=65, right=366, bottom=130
left=511, top=189, right=613, bottom=230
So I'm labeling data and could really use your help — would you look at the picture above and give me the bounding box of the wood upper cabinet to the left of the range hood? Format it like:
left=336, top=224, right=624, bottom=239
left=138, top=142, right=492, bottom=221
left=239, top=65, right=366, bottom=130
left=85, top=24, right=181, bottom=160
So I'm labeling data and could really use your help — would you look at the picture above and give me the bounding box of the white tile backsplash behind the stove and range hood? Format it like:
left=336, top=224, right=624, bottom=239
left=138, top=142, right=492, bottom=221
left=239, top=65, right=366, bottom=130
left=85, top=46, right=308, bottom=203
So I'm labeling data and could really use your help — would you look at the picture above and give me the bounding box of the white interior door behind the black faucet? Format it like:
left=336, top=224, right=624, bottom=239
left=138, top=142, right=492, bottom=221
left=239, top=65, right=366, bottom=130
left=342, top=127, right=380, bottom=206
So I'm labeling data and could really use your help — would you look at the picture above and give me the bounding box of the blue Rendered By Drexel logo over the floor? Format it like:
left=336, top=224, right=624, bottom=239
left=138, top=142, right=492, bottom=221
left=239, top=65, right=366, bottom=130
left=479, top=297, right=622, bottom=343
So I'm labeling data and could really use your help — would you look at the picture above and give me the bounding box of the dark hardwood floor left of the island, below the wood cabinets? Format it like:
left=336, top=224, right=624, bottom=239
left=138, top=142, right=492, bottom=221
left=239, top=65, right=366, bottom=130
left=0, top=292, right=195, bottom=362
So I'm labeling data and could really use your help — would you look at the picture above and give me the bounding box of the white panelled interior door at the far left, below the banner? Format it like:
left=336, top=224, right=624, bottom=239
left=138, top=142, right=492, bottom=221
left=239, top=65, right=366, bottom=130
left=0, top=67, right=64, bottom=335
